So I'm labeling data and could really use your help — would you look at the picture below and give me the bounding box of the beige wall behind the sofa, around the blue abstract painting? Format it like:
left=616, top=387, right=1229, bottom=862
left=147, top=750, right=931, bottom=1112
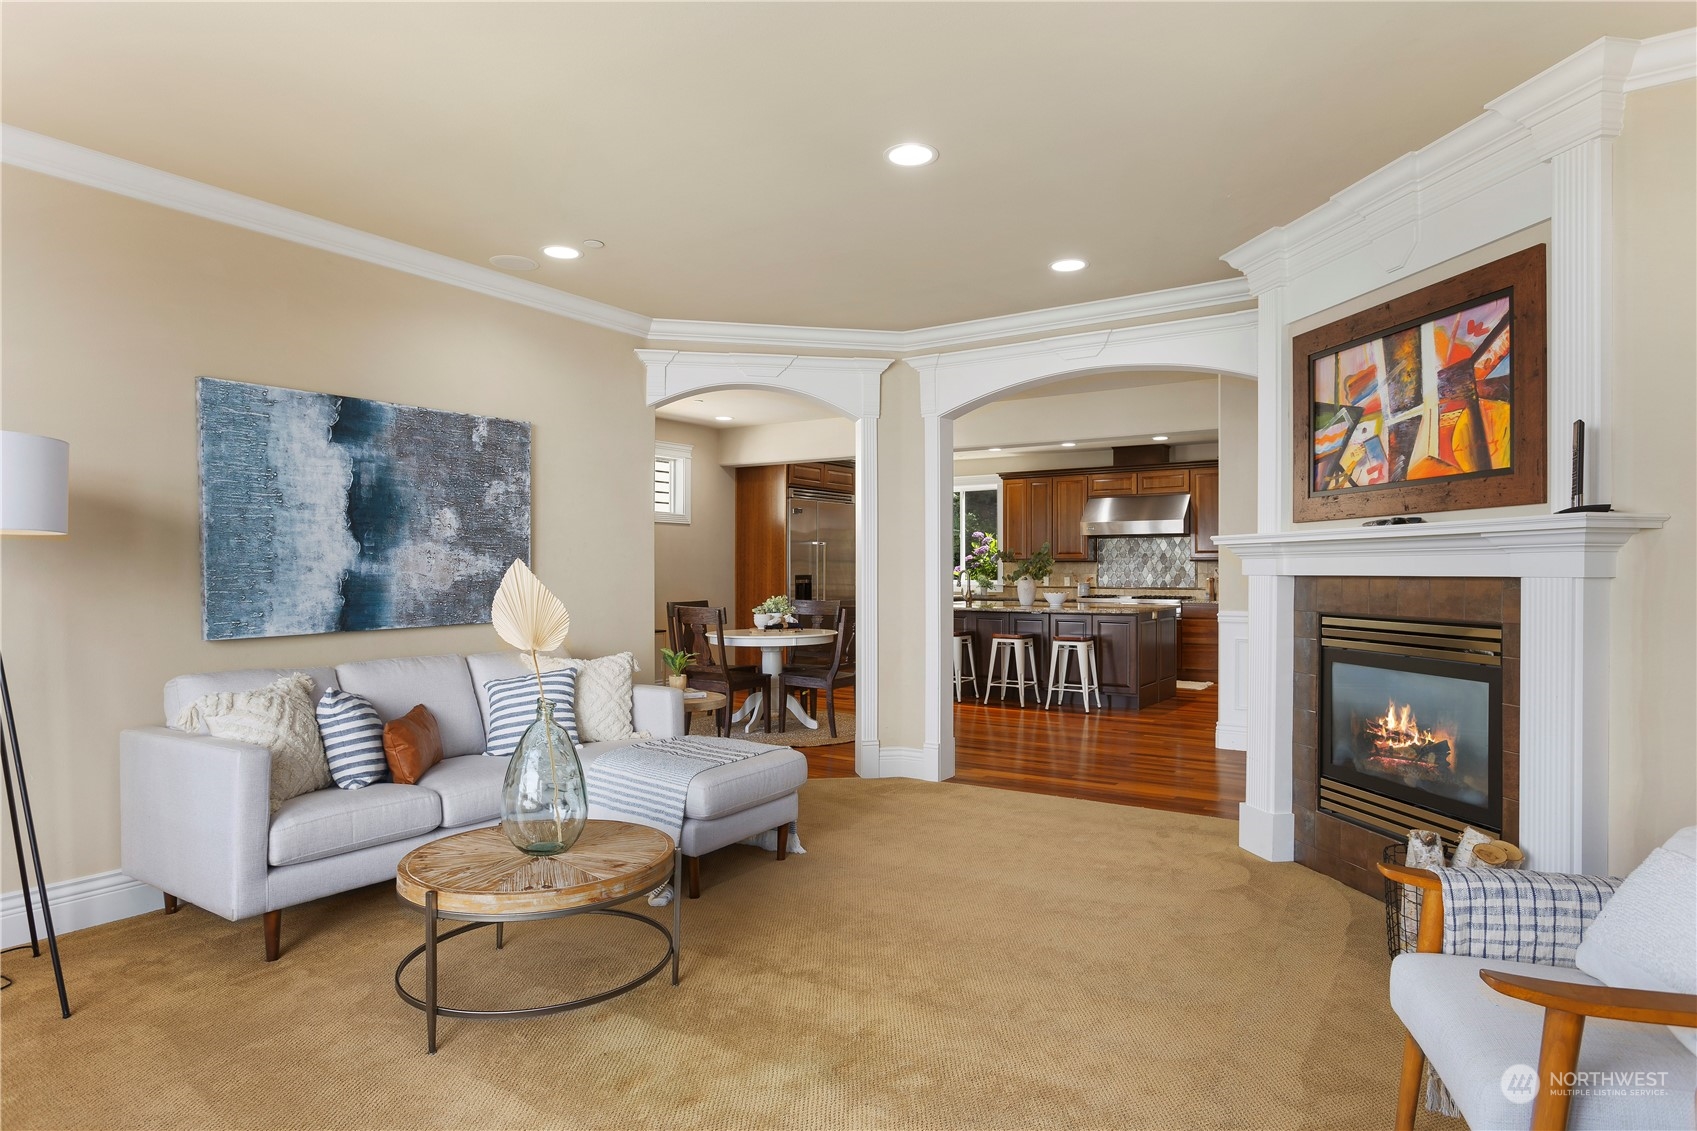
left=0, top=166, right=655, bottom=890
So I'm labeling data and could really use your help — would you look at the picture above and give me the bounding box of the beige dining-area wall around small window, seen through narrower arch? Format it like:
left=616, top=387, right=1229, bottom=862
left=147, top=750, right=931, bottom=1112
left=645, top=419, right=736, bottom=674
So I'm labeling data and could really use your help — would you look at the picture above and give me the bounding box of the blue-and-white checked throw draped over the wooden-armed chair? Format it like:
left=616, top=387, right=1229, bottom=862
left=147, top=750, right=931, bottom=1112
left=1425, top=868, right=1621, bottom=1117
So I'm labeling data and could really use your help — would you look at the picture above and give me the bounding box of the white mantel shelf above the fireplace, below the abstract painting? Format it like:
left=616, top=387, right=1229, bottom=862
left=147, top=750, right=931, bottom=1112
left=1215, top=511, right=1668, bottom=577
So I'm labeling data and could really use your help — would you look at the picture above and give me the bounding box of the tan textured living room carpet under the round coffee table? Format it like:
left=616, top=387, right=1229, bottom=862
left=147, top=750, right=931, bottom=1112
left=0, top=779, right=1459, bottom=1129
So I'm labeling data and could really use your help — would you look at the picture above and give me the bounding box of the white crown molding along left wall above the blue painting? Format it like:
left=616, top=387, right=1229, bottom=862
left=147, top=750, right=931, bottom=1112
left=0, top=126, right=652, bottom=338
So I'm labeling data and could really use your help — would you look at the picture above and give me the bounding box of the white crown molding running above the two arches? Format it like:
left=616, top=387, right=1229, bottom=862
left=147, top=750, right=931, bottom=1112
left=648, top=279, right=1252, bottom=353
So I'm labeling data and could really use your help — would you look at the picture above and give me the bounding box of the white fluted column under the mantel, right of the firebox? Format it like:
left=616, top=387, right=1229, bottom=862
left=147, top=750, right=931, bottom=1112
left=1521, top=577, right=1609, bottom=875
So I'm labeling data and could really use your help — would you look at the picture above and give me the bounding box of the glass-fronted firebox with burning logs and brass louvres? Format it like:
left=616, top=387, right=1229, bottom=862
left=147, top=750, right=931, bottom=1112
left=1319, top=615, right=1504, bottom=842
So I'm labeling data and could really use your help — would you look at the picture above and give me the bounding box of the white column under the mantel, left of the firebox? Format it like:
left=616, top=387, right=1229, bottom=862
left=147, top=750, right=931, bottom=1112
left=1237, top=574, right=1297, bottom=861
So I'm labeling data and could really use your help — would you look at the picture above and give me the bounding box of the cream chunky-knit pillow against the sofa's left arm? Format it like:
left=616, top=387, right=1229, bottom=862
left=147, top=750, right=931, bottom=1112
left=176, top=671, right=334, bottom=817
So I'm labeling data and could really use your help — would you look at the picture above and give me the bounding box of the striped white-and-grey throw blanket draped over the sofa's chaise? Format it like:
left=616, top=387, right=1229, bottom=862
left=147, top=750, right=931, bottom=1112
left=584, top=735, right=806, bottom=852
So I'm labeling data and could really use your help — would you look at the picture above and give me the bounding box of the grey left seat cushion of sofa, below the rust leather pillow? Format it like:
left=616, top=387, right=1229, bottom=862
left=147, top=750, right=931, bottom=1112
left=266, top=781, right=441, bottom=866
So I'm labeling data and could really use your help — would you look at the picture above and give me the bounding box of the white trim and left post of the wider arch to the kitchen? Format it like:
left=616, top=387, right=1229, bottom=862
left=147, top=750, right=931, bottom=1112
left=908, top=311, right=1257, bottom=781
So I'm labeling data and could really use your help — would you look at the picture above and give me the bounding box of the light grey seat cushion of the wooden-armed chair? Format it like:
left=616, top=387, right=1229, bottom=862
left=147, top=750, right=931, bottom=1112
left=1390, top=954, right=1697, bottom=1131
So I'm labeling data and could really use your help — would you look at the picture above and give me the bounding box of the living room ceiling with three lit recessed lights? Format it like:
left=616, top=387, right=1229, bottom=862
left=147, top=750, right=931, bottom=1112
left=0, top=3, right=1694, bottom=329
